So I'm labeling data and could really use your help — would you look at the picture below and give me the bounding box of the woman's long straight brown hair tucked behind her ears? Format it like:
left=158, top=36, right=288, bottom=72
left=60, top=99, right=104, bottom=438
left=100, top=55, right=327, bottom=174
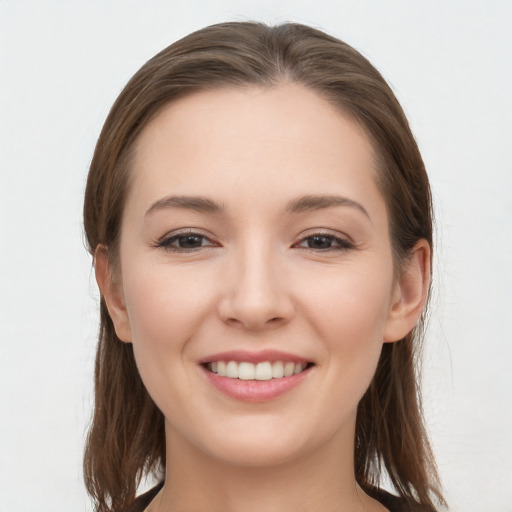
left=84, top=22, right=445, bottom=512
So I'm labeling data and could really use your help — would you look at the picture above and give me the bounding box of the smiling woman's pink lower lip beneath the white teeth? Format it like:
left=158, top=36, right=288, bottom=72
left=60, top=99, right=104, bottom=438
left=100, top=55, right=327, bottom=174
left=203, top=368, right=312, bottom=402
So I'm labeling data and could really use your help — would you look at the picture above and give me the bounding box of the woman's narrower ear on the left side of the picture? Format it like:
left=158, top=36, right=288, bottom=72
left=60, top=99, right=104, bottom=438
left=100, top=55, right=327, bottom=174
left=94, top=245, right=132, bottom=343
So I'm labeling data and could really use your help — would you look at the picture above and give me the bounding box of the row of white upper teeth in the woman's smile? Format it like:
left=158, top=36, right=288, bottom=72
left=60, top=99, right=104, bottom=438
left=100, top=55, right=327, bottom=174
left=208, top=361, right=306, bottom=380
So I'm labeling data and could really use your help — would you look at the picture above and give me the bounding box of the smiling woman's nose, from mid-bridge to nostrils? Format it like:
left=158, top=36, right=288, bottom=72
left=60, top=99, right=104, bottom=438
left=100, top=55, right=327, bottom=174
left=219, top=246, right=294, bottom=331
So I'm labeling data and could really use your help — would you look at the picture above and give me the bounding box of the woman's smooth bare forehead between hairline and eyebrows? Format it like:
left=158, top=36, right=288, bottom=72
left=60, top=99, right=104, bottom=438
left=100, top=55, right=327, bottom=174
left=129, top=84, right=384, bottom=216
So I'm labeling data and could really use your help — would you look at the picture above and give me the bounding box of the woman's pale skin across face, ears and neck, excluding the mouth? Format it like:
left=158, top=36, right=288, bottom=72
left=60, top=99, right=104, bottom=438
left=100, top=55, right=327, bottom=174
left=95, top=84, right=430, bottom=512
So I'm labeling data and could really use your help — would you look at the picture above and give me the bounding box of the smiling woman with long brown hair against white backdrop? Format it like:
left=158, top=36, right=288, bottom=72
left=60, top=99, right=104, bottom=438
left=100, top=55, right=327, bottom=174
left=84, top=23, right=444, bottom=512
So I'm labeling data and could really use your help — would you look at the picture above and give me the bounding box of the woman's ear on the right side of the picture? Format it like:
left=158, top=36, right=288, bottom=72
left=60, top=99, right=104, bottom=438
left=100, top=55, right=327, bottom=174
left=383, top=239, right=431, bottom=343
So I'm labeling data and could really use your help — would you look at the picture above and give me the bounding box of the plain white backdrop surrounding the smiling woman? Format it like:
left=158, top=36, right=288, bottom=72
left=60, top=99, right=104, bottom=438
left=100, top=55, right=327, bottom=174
left=0, top=0, right=512, bottom=512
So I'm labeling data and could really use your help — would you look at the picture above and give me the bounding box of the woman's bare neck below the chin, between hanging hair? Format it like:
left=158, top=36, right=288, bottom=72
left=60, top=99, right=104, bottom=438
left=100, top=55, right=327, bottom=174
left=154, top=424, right=381, bottom=512
